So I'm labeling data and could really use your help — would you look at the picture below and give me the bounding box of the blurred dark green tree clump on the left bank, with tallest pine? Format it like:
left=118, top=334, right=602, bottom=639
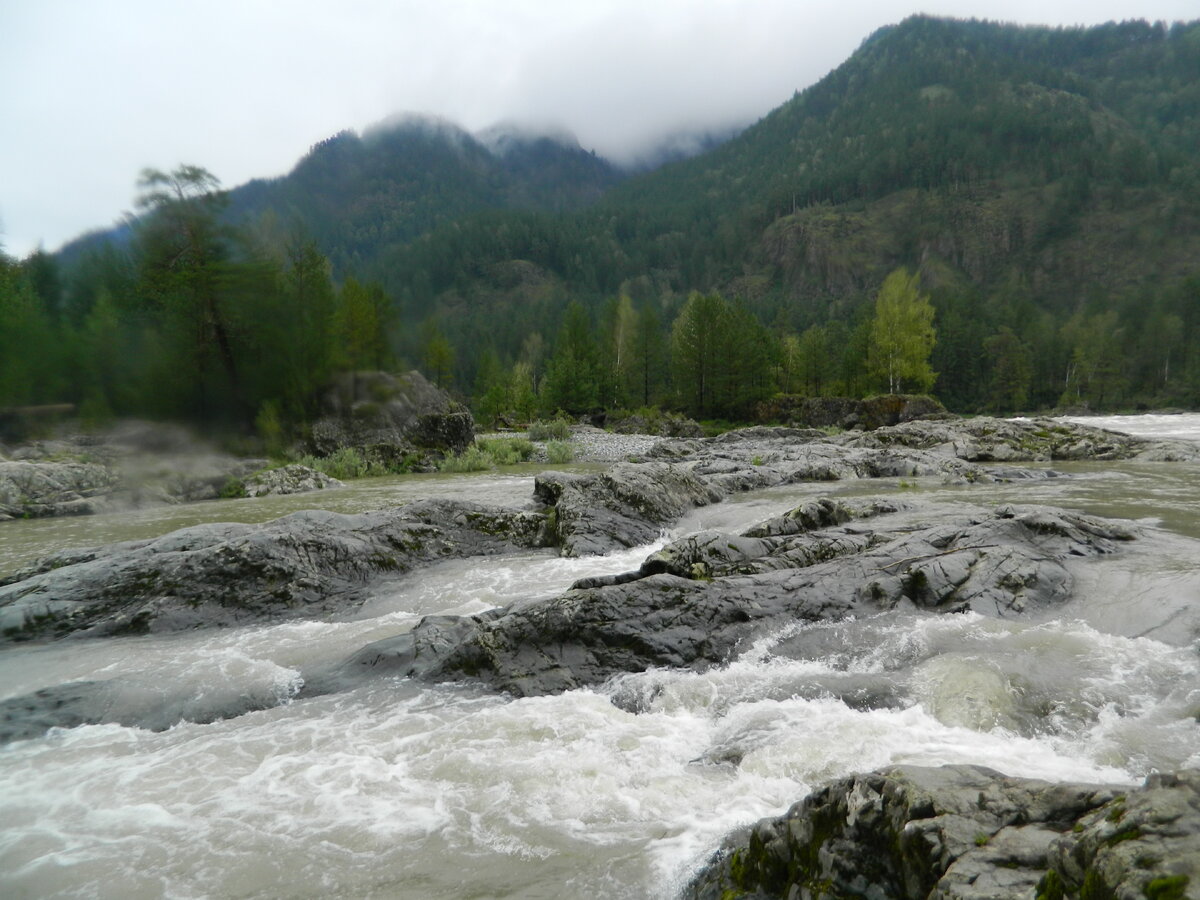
left=0, top=166, right=395, bottom=428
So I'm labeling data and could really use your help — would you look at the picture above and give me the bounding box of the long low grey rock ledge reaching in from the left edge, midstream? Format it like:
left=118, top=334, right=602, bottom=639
left=0, top=500, right=546, bottom=641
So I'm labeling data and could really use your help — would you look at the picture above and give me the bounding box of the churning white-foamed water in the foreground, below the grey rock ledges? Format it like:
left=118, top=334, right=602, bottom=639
left=0, top=614, right=1196, bottom=899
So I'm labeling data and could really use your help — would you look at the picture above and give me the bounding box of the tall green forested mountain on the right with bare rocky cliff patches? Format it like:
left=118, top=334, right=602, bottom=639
left=374, top=16, right=1200, bottom=408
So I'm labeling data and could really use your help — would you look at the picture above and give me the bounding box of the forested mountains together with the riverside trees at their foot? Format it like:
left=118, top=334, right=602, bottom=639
left=16, top=16, right=1200, bottom=427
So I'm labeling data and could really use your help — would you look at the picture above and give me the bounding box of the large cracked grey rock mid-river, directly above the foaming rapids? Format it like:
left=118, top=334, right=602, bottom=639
left=306, top=500, right=1133, bottom=696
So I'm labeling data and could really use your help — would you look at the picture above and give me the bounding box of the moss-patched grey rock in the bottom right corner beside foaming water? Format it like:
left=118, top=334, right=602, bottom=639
left=683, top=766, right=1200, bottom=900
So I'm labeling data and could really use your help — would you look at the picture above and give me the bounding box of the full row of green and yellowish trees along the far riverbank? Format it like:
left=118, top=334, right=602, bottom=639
left=9, top=157, right=1200, bottom=439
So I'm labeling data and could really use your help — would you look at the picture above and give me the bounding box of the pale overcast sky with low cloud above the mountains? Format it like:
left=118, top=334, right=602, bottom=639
left=0, top=0, right=1200, bottom=257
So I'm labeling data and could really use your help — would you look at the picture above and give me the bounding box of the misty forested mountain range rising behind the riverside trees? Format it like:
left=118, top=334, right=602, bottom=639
left=42, top=16, right=1200, bottom=409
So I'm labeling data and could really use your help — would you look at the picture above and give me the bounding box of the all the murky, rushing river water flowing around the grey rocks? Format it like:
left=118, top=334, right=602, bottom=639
left=0, top=415, right=1200, bottom=900
